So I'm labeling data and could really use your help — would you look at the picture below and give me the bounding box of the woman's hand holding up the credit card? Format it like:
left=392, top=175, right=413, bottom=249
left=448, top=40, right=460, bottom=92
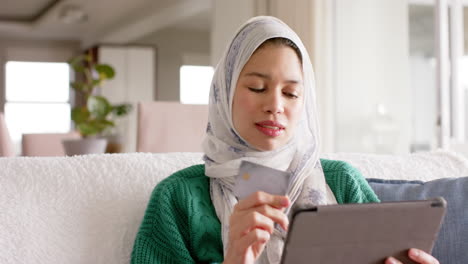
left=224, top=192, right=290, bottom=264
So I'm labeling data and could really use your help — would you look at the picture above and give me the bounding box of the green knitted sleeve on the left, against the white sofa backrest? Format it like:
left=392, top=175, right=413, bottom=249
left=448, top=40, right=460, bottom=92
left=131, top=177, right=195, bottom=264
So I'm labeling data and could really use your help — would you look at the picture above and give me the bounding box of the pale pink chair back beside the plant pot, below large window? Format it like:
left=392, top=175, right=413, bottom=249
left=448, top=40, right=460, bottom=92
left=21, top=131, right=80, bottom=157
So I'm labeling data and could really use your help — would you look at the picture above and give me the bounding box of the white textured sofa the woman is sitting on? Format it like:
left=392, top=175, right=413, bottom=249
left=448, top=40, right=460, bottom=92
left=0, top=151, right=468, bottom=264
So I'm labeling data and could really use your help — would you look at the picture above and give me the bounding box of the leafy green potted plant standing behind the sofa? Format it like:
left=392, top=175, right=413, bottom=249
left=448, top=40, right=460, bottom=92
left=63, top=54, right=131, bottom=155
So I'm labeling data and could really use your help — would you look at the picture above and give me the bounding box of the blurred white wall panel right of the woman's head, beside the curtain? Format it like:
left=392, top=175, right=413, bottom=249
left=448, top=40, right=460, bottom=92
left=335, top=0, right=411, bottom=153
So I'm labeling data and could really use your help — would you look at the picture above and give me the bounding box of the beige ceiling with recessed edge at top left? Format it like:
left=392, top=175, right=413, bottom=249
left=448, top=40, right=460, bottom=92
left=0, top=0, right=211, bottom=46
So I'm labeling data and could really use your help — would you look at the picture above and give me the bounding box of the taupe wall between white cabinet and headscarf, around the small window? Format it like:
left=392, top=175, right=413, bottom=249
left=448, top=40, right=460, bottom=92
left=138, top=28, right=210, bottom=101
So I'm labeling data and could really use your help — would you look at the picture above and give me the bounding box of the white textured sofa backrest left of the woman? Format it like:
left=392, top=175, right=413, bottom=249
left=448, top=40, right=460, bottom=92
left=0, top=153, right=202, bottom=264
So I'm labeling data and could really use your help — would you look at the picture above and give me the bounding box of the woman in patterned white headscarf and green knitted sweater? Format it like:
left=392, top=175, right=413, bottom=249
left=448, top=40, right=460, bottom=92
left=132, top=17, right=437, bottom=264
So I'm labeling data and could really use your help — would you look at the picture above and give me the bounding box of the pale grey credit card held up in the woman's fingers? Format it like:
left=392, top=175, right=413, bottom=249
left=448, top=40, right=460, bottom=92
left=234, top=161, right=291, bottom=200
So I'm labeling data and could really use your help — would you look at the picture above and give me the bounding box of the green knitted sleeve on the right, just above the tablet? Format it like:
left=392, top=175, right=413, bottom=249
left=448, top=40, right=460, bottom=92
left=321, top=160, right=380, bottom=204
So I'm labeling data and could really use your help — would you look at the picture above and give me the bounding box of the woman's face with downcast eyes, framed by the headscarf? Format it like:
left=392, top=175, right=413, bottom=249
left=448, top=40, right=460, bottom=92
left=232, top=44, right=304, bottom=151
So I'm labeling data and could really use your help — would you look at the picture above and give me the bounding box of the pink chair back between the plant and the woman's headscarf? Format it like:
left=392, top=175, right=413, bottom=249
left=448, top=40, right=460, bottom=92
left=137, top=102, right=208, bottom=152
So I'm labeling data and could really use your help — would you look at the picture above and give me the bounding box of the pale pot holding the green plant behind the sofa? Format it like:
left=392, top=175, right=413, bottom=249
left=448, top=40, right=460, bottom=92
left=62, top=138, right=107, bottom=156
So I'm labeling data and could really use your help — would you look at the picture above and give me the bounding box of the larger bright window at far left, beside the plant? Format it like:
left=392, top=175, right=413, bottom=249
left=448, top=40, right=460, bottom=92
left=5, top=61, right=70, bottom=152
